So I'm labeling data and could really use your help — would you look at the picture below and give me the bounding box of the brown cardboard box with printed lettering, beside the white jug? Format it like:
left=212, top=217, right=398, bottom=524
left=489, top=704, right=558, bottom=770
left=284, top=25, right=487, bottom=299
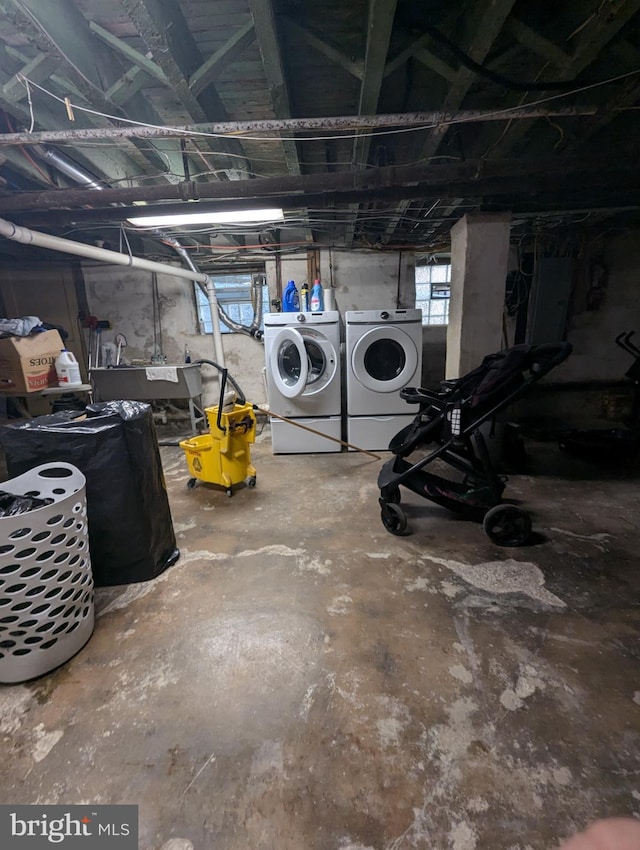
left=0, top=331, right=64, bottom=395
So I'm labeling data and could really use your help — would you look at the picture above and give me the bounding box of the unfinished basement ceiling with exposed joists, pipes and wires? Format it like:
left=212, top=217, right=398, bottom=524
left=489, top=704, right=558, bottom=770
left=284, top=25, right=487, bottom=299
left=0, top=0, right=640, bottom=267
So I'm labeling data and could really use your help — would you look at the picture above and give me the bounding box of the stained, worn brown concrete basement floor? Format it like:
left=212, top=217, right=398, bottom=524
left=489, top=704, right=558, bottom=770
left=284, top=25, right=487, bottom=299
left=0, top=424, right=640, bottom=850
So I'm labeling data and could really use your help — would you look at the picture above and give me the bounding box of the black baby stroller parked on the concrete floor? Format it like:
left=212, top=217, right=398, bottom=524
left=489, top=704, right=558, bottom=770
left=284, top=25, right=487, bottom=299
left=378, top=342, right=571, bottom=546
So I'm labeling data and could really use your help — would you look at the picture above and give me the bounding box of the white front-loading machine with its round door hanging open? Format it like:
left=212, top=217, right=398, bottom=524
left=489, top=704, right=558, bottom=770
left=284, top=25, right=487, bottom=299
left=264, top=310, right=342, bottom=454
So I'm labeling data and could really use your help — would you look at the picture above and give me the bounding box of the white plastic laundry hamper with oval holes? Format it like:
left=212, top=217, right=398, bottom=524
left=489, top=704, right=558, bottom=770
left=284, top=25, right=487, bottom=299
left=0, top=463, right=94, bottom=683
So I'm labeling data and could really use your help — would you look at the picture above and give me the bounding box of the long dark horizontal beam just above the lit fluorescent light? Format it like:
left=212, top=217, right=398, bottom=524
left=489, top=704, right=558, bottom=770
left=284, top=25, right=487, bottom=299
left=5, top=158, right=640, bottom=220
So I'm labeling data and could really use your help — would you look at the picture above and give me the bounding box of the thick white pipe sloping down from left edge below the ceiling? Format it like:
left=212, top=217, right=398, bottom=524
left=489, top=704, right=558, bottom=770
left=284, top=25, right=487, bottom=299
left=0, top=218, right=208, bottom=284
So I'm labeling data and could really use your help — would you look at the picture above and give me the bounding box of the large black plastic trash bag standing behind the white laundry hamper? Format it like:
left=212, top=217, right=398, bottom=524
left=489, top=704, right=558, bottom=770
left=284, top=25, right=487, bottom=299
left=0, top=401, right=180, bottom=587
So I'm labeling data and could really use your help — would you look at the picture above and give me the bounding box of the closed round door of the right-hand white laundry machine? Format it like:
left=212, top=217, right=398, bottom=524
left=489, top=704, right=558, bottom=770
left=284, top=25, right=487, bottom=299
left=351, top=326, right=418, bottom=393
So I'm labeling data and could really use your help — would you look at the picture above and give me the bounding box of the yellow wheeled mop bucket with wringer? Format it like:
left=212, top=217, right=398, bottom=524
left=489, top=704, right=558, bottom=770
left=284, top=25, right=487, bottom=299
left=180, top=370, right=256, bottom=496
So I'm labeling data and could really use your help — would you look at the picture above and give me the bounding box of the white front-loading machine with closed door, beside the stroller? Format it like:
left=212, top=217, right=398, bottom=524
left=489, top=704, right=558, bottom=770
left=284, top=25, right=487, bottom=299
left=345, top=309, right=422, bottom=449
